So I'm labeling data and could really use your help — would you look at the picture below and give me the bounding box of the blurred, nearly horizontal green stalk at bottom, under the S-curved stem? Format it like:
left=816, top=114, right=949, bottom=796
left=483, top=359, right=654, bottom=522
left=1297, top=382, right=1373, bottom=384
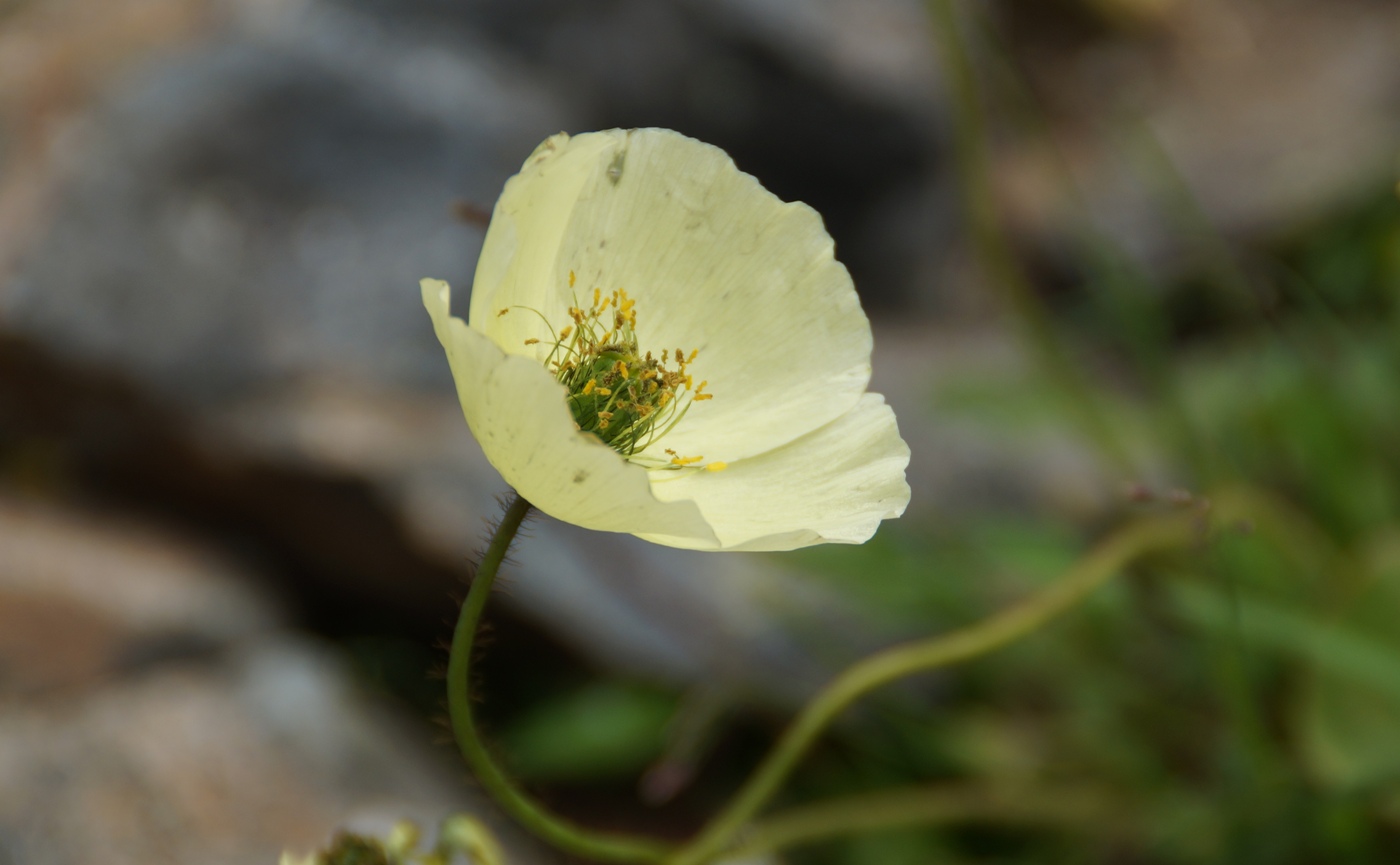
left=732, top=784, right=1131, bottom=861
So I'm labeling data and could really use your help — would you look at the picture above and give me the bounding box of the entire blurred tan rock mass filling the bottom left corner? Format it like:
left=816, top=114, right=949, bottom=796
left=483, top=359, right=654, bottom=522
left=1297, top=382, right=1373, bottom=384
left=0, top=497, right=542, bottom=865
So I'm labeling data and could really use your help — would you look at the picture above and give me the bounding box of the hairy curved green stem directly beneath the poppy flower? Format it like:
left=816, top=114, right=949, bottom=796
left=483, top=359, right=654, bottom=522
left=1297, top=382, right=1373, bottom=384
left=447, top=495, right=669, bottom=862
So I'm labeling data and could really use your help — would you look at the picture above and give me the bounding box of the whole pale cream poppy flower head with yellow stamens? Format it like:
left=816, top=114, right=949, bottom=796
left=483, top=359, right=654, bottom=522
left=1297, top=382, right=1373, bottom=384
left=423, top=129, right=909, bottom=550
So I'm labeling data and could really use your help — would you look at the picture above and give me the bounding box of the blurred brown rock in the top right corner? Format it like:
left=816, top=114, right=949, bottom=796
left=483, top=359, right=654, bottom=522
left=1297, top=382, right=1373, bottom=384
left=997, top=0, right=1400, bottom=265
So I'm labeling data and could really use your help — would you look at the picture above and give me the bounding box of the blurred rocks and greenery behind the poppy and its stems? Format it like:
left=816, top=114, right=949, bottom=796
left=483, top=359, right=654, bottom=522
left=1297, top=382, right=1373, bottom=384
left=0, top=0, right=1400, bottom=865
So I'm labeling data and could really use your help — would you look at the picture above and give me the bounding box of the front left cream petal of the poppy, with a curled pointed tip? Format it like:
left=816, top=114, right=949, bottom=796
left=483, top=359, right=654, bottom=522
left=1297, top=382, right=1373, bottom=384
left=421, top=280, right=717, bottom=547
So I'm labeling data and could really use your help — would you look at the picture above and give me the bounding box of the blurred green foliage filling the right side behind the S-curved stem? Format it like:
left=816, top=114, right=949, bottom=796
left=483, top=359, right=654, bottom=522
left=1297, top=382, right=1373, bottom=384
left=767, top=185, right=1400, bottom=865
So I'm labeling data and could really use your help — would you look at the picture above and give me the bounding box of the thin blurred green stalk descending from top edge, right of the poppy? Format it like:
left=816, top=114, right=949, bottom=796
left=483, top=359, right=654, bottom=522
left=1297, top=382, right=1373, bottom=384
left=928, top=0, right=1135, bottom=474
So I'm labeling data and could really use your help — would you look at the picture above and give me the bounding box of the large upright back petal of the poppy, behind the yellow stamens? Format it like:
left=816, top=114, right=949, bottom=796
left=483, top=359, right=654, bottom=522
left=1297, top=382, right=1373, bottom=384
left=472, top=129, right=871, bottom=463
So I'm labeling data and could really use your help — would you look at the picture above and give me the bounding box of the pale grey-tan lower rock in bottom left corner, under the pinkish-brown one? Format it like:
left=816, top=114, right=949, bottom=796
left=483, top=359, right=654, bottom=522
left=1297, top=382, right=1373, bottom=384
left=0, top=629, right=546, bottom=865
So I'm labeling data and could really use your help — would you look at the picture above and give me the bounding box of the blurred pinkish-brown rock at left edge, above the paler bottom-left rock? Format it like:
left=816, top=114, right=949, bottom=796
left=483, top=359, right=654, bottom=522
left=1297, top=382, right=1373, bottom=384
left=0, top=487, right=277, bottom=698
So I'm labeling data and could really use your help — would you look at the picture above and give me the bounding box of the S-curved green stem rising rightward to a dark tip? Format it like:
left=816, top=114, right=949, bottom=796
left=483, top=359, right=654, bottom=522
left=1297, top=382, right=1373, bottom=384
left=668, top=514, right=1197, bottom=865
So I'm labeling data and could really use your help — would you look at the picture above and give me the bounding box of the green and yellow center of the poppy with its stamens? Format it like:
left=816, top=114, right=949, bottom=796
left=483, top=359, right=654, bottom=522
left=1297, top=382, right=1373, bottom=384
left=501, top=273, right=725, bottom=472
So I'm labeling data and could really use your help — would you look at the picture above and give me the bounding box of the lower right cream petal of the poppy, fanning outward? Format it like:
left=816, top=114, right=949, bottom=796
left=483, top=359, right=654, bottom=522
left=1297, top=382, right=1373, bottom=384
left=637, top=393, right=909, bottom=550
